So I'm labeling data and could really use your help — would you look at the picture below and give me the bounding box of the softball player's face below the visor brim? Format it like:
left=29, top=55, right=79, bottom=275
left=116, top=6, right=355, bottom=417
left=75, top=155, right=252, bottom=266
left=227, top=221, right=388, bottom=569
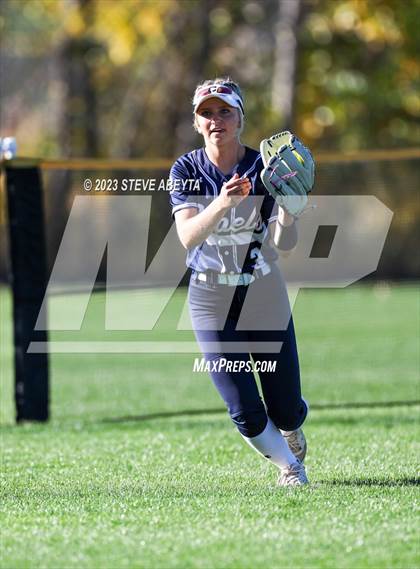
left=196, top=98, right=241, bottom=146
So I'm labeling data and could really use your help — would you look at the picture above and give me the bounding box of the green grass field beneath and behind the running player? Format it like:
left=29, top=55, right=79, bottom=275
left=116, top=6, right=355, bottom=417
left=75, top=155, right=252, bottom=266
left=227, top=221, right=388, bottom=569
left=0, top=285, right=420, bottom=569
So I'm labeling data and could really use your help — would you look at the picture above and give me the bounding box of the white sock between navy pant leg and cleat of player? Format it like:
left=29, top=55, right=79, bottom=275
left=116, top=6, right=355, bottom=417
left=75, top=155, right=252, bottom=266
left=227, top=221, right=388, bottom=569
left=242, top=418, right=296, bottom=468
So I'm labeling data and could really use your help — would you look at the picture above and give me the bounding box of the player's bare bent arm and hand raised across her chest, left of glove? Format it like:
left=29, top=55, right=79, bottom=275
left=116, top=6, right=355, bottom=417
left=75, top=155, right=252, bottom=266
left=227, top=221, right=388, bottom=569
left=175, top=174, right=251, bottom=249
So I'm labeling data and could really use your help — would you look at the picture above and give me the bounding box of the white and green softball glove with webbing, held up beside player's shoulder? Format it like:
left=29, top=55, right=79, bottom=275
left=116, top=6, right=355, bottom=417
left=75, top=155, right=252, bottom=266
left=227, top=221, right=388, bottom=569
left=260, top=130, right=315, bottom=217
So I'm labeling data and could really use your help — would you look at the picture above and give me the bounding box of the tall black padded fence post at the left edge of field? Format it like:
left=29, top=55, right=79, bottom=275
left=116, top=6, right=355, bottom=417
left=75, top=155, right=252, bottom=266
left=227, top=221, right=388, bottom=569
left=5, top=160, right=49, bottom=422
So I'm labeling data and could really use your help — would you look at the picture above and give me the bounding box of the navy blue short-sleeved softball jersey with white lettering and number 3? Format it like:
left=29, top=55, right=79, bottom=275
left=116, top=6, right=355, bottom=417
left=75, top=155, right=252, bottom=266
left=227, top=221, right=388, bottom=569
left=170, top=147, right=278, bottom=273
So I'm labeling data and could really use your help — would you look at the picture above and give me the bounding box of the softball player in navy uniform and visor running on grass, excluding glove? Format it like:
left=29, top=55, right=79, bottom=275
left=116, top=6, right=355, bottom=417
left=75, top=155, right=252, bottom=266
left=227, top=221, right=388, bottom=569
left=170, top=79, right=308, bottom=486
